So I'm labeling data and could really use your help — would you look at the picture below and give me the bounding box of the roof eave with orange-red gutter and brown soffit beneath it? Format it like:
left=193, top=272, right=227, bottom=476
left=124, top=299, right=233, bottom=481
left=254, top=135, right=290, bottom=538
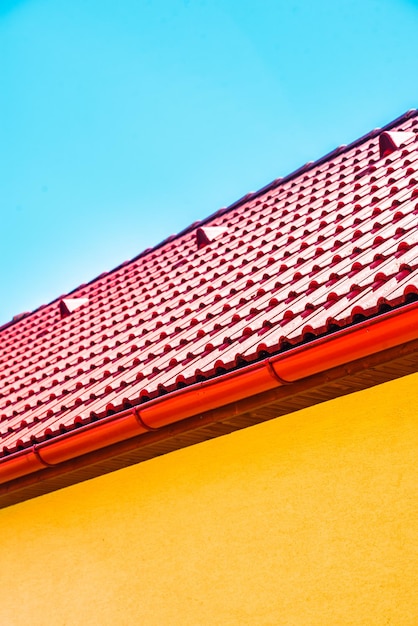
left=0, top=302, right=418, bottom=506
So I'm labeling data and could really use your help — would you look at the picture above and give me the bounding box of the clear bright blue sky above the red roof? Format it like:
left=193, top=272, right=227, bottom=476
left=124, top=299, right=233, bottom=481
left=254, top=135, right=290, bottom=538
left=0, top=0, right=418, bottom=323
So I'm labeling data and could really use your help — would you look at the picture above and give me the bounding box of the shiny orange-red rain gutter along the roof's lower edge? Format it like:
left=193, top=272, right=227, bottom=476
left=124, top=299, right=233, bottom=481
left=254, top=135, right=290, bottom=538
left=0, top=303, right=418, bottom=483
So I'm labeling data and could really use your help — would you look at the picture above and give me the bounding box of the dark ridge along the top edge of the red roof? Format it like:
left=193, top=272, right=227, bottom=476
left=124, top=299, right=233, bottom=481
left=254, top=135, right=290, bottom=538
left=0, top=109, right=418, bottom=333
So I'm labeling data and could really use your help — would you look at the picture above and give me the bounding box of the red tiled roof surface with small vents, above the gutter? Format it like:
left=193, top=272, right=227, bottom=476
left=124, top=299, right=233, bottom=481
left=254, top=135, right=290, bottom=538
left=0, top=111, right=418, bottom=458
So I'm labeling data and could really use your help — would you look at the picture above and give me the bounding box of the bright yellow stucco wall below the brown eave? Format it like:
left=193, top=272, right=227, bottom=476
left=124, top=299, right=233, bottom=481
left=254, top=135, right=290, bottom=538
left=0, top=375, right=418, bottom=626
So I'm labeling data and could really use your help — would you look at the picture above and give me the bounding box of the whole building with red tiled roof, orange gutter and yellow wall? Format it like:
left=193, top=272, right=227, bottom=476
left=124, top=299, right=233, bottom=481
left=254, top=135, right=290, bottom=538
left=0, top=111, right=418, bottom=625
